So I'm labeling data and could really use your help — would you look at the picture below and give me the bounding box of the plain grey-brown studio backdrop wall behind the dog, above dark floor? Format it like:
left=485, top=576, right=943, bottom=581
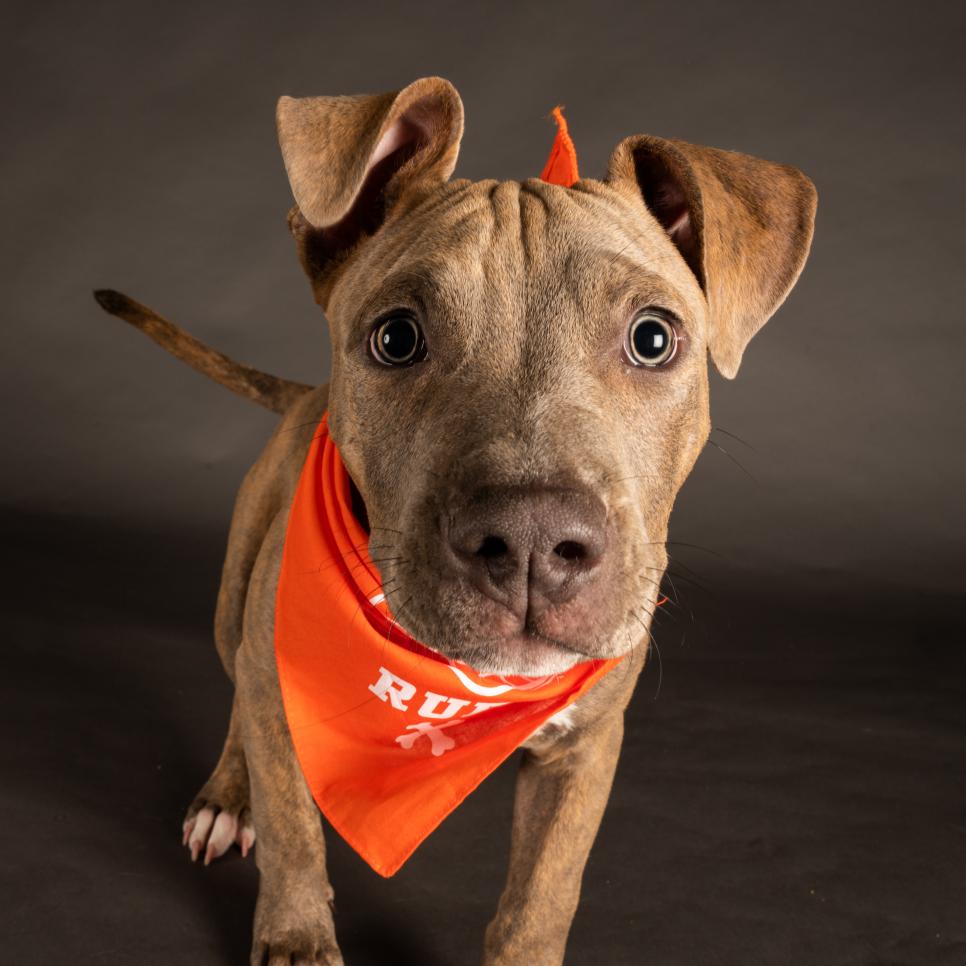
left=0, top=2, right=966, bottom=592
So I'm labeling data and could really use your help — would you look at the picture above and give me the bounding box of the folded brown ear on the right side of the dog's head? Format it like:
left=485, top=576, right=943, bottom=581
left=607, top=135, right=817, bottom=379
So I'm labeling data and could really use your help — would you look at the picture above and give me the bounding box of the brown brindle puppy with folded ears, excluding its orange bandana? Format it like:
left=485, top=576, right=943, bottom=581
left=96, top=77, right=816, bottom=966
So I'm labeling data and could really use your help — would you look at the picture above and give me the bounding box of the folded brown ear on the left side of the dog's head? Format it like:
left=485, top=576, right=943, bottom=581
left=276, top=77, right=463, bottom=301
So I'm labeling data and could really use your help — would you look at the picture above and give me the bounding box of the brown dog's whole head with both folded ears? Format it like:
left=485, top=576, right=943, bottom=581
left=278, top=78, right=815, bottom=674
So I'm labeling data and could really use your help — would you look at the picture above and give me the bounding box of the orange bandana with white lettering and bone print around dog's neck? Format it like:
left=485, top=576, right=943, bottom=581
left=275, top=111, right=619, bottom=876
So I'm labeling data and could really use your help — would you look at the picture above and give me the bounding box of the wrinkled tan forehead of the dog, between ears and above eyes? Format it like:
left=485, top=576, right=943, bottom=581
left=329, top=179, right=705, bottom=324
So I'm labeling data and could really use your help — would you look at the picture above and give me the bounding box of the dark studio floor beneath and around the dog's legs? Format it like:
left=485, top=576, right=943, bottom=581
left=0, top=517, right=966, bottom=966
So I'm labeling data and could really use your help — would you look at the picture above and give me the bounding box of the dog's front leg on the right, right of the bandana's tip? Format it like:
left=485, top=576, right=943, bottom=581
left=483, top=712, right=623, bottom=966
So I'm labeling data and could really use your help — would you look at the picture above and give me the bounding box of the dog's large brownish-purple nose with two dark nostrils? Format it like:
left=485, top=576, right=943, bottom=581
left=445, top=487, right=607, bottom=619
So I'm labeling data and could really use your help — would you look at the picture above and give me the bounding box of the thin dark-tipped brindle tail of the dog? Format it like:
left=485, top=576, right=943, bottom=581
left=94, top=288, right=312, bottom=413
